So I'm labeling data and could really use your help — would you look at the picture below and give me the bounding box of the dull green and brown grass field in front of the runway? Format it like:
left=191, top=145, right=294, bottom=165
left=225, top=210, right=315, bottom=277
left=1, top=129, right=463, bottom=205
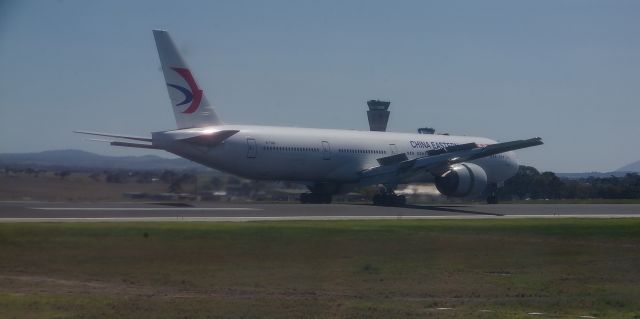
left=0, top=219, right=640, bottom=318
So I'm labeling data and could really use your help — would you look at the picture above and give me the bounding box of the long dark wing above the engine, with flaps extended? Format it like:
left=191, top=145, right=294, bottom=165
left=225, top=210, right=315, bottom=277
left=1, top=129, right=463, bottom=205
left=360, top=137, right=543, bottom=185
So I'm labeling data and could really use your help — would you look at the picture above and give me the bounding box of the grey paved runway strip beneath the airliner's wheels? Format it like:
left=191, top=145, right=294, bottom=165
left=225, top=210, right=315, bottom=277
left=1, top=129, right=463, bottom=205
left=0, top=202, right=640, bottom=222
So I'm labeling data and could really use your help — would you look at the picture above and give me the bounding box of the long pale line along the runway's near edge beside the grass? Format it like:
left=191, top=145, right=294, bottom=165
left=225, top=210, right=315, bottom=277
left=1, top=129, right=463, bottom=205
left=0, top=214, right=640, bottom=223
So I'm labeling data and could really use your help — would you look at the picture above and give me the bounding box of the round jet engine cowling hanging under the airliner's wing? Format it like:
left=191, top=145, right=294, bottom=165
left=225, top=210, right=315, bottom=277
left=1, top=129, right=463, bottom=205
left=436, top=163, right=487, bottom=197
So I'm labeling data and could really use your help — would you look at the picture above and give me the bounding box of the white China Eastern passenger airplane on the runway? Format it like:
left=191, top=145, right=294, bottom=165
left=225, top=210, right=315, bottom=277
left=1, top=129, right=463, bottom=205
left=74, top=30, right=543, bottom=206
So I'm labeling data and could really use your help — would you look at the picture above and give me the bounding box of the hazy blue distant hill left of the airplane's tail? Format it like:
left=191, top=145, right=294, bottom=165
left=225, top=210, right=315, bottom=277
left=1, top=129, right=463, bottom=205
left=0, top=150, right=206, bottom=170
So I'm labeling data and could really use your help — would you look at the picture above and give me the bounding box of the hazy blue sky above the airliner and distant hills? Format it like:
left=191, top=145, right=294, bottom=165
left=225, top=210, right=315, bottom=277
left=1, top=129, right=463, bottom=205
left=0, top=0, right=640, bottom=172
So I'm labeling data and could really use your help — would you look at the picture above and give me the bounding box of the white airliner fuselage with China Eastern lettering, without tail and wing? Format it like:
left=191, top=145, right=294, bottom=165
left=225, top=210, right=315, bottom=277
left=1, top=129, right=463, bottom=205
left=153, top=125, right=518, bottom=190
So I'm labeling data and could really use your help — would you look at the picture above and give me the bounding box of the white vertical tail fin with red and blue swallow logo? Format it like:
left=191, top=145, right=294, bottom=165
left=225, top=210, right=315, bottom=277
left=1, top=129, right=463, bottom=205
left=153, top=30, right=222, bottom=128
